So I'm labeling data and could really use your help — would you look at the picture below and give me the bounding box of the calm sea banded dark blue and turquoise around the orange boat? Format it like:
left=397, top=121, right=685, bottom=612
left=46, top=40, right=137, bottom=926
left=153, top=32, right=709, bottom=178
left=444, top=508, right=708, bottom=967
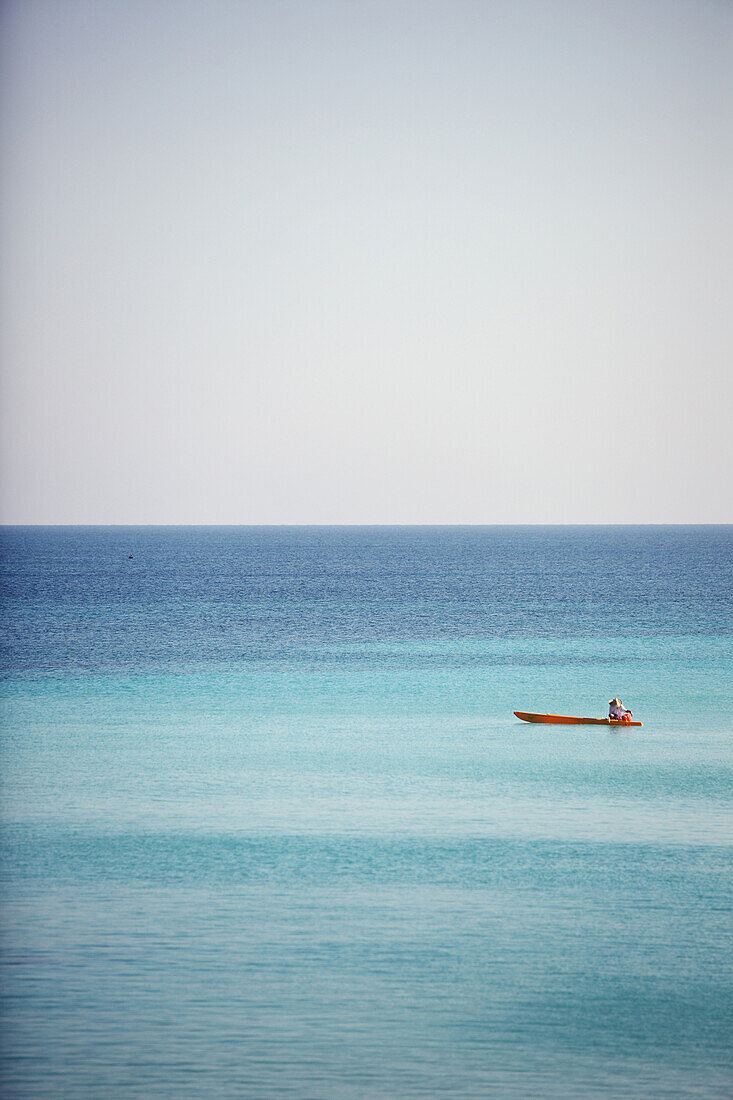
left=1, top=527, right=733, bottom=1100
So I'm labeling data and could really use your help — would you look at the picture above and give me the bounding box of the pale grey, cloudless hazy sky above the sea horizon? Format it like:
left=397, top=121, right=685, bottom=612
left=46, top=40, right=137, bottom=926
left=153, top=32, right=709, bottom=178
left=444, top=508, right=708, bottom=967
left=0, top=0, right=733, bottom=524
